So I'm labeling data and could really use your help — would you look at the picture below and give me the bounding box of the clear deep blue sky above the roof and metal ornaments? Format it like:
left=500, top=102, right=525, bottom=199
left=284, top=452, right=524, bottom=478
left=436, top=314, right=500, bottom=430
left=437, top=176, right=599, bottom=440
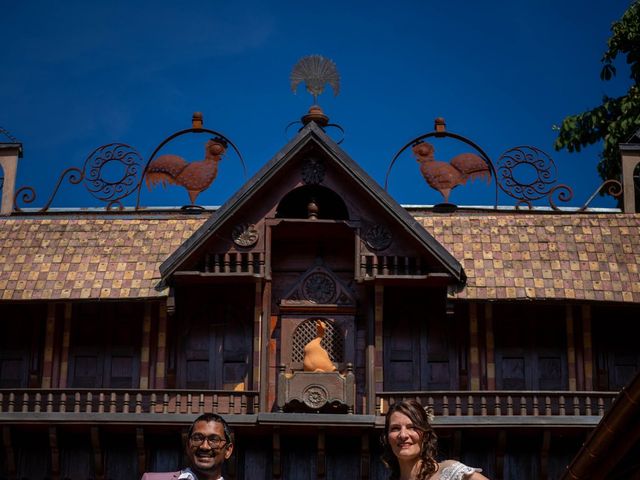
left=0, top=0, right=629, bottom=207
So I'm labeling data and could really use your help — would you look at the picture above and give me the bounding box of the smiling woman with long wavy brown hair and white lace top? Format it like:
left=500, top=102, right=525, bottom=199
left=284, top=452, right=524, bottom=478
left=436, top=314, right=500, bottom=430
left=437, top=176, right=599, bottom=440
left=382, top=400, right=488, bottom=480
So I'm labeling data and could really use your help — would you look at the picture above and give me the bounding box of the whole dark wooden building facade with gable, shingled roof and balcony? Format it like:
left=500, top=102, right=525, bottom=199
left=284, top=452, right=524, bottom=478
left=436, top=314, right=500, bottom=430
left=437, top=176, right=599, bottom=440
left=0, top=122, right=640, bottom=480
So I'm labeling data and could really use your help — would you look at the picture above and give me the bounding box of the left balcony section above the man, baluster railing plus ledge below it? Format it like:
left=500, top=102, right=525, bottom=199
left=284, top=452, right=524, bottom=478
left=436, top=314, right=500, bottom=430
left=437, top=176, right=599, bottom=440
left=0, top=389, right=258, bottom=423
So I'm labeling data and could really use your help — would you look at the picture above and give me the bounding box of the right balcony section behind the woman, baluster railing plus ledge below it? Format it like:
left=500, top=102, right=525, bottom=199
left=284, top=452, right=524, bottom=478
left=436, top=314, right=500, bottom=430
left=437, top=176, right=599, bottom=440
left=376, top=390, right=618, bottom=426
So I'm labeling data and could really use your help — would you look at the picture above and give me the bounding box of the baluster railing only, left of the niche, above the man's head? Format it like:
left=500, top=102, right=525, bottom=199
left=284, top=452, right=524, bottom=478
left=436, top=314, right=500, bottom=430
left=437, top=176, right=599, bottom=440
left=0, top=389, right=258, bottom=415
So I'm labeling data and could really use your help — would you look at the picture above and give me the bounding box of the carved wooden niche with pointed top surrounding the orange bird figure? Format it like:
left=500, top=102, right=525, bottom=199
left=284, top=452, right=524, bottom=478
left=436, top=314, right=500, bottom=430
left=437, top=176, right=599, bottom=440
left=278, top=264, right=356, bottom=413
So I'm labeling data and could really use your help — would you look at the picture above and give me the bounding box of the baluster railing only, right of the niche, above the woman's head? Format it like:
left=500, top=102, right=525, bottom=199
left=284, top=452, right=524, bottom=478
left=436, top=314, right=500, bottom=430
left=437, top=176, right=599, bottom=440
left=376, top=390, right=618, bottom=417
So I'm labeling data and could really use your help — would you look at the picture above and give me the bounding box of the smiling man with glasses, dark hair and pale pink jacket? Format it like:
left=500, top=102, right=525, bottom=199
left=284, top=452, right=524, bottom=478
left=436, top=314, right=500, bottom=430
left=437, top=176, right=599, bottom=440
left=142, top=413, right=233, bottom=480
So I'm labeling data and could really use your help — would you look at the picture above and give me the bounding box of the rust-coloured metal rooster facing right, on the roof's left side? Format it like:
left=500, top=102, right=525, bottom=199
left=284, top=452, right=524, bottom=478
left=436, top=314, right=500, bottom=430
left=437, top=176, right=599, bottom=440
left=145, top=138, right=227, bottom=204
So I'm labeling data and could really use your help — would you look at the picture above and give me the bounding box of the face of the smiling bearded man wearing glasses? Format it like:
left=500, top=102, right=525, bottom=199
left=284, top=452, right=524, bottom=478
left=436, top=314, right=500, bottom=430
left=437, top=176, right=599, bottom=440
left=187, top=421, right=233, bottom=475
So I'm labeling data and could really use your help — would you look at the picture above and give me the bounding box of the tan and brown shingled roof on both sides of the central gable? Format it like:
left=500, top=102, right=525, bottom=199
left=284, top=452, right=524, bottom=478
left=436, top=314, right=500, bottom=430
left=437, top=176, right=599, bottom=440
left=0, top=211, right=640, bottom=303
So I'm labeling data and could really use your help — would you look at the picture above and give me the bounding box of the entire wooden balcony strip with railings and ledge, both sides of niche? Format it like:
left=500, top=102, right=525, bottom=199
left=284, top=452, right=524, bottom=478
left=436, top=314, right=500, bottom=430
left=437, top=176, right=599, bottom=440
left=0, top=389, right=617, bottom=427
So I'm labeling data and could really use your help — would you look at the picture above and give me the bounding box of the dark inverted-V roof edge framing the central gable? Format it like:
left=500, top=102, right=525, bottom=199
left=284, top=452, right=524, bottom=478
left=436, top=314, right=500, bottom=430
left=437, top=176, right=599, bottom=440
left=160, top=122, right=466, bottom=284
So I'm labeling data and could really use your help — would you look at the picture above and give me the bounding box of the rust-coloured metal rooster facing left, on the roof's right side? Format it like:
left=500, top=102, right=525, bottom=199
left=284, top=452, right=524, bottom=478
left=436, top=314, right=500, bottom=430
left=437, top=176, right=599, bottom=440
left=412, top=142, right=491, bottom=202
